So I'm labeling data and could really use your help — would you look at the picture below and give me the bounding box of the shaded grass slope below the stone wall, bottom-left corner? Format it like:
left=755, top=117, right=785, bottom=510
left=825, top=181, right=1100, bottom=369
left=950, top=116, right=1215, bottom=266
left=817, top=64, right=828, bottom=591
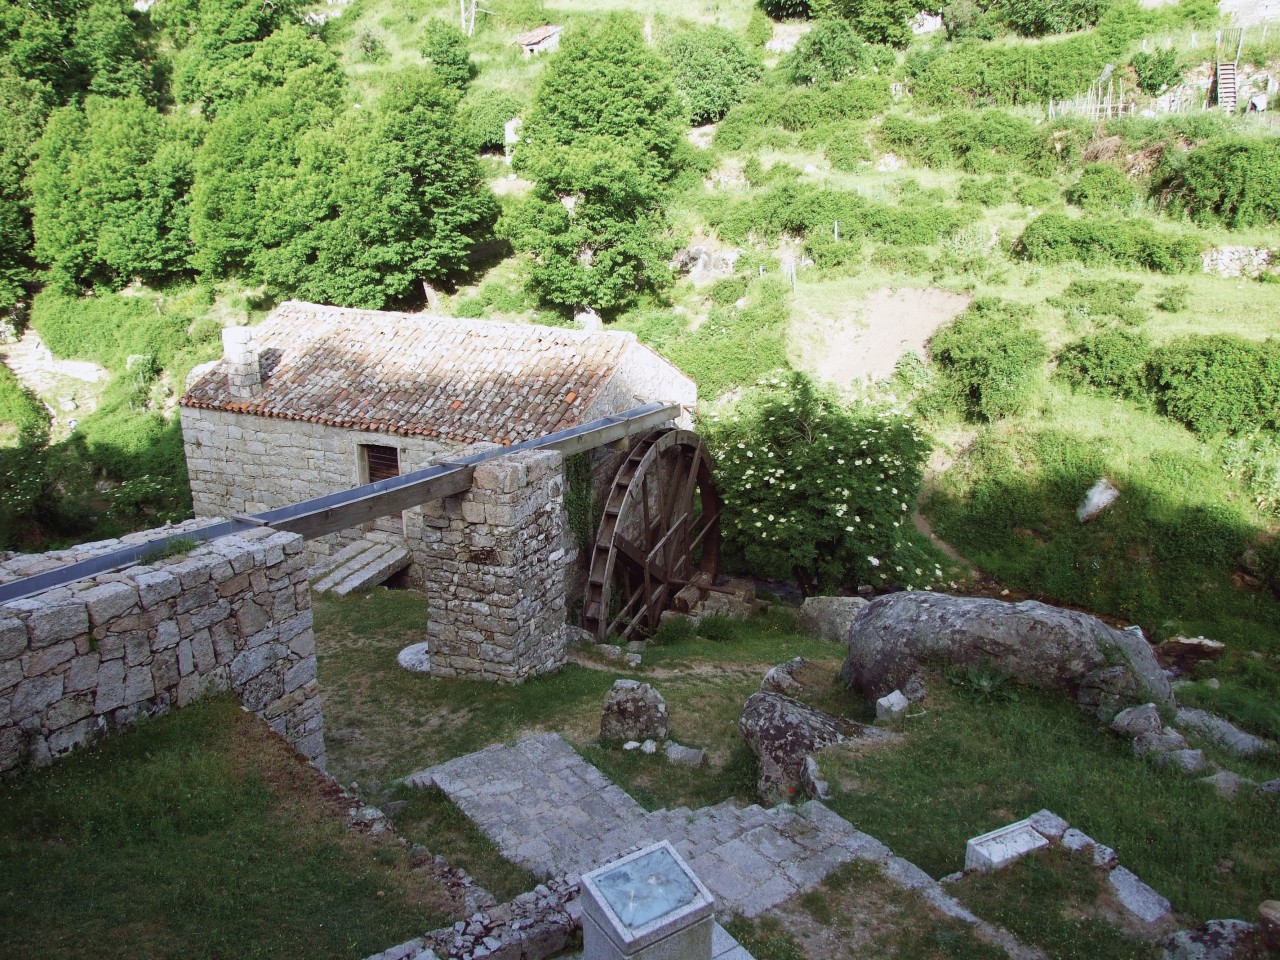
left=0, top=698, right=453, bottom=960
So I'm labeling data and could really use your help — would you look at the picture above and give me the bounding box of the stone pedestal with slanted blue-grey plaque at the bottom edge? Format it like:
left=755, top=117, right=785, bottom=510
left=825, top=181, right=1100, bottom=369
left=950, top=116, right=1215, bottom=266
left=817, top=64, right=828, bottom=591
left=581, top=840, right=716, bottom=960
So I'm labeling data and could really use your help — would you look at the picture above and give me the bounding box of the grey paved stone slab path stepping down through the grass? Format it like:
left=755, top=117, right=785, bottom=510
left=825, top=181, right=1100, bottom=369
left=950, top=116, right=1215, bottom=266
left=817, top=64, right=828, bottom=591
left=408, top=733, right=891, bottom=916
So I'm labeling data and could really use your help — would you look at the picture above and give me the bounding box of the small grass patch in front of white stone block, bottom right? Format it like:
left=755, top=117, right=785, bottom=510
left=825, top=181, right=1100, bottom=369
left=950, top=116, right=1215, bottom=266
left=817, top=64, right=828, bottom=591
left=950, top=849, right=1161, bottom=960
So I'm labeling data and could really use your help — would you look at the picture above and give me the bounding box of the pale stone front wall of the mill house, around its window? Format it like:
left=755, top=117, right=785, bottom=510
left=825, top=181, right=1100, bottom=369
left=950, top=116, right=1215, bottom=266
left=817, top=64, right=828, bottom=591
left=182, top=407, right=455, bottom=570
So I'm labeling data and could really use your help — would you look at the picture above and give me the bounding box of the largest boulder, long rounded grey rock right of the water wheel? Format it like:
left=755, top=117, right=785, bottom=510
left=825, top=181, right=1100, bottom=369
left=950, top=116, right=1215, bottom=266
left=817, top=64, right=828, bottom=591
left=841, top=591, right=1172, bottom=710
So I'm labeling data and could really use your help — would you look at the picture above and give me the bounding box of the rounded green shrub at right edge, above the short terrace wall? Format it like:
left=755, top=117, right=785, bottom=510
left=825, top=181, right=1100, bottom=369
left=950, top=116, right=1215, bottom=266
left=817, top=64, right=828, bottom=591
left=1178, top=137, right=1280, bottom=227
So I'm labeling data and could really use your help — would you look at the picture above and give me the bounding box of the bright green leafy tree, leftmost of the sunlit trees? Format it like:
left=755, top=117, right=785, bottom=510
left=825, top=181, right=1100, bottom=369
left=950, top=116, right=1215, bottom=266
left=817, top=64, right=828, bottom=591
left=31, top=97, right=198, bottom=293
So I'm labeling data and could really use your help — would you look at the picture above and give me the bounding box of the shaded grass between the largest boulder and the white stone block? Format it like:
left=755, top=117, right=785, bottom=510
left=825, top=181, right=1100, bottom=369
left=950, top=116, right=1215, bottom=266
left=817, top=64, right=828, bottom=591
left=822, top=681, right=1280, bottom=923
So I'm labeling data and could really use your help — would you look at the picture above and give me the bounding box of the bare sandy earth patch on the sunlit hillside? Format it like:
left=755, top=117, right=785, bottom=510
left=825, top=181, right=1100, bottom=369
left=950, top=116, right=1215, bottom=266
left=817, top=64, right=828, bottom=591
left=791, top=287, right=970, bottom=387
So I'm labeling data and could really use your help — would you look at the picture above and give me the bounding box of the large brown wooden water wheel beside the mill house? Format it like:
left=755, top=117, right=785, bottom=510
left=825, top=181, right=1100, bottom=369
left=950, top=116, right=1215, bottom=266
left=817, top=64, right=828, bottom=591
left=582, top=428, right=719, bottom=640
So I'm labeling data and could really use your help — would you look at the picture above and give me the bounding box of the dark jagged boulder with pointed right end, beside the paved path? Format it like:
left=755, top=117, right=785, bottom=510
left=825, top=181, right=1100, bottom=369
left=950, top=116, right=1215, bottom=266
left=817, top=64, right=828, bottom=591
left=737, top=692, right=892, bottom=801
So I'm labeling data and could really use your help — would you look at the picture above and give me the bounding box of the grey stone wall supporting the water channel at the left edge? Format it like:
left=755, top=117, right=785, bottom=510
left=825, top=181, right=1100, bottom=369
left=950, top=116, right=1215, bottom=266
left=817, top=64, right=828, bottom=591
left=0, top=529, right=325, bottom=772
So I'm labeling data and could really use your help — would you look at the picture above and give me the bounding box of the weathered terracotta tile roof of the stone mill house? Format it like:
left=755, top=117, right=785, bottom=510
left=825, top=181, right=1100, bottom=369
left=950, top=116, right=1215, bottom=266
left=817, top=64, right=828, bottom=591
left=182, top=301, right=636, bottom=443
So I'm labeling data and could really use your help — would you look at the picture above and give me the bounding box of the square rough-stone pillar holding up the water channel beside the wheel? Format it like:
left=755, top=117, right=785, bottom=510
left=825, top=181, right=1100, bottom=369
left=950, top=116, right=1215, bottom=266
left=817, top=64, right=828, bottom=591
left=421, top=451, right=575, bottom=684
